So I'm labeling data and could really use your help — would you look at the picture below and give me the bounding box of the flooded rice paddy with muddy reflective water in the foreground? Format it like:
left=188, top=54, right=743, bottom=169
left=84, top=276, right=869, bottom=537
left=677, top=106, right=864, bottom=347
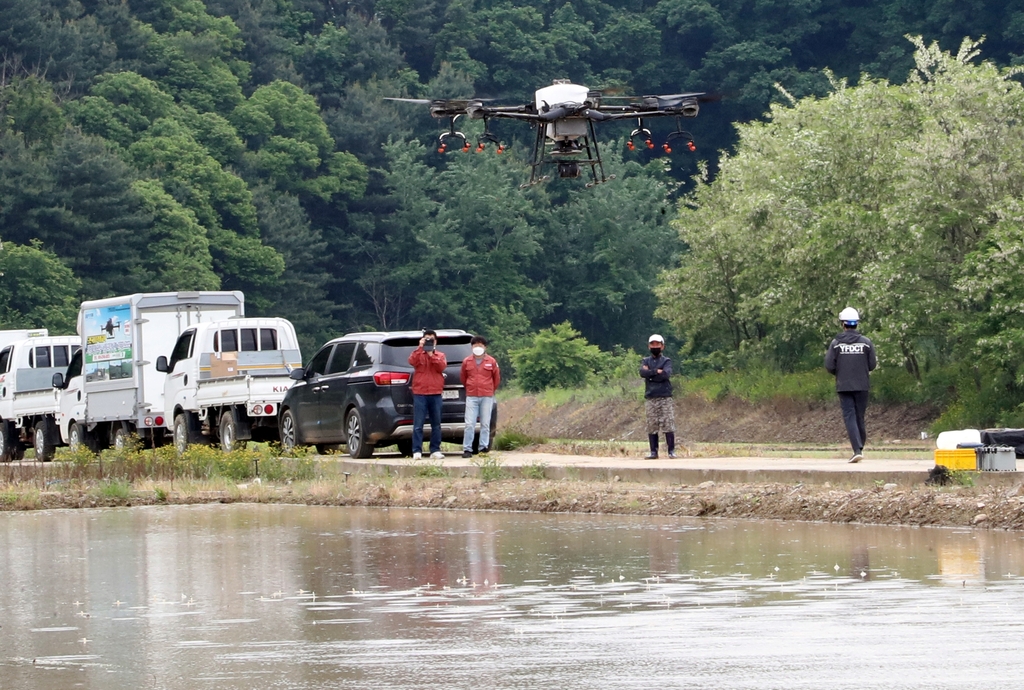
left=0, top=505, right=1024, bottom=690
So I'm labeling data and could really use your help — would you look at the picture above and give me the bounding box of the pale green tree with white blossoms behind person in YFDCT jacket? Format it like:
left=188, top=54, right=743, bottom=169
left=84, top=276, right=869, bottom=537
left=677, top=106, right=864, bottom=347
left=658, top=38, right=1024, bottom=383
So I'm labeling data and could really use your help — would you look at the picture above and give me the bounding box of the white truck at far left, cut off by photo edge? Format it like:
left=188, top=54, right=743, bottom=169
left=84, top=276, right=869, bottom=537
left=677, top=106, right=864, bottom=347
left=0, top=331, right=81, bottom=462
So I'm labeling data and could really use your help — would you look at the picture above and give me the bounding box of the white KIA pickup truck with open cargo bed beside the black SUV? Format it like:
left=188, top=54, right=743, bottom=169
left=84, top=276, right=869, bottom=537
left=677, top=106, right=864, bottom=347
left=157, top=318, right=302, bottom=452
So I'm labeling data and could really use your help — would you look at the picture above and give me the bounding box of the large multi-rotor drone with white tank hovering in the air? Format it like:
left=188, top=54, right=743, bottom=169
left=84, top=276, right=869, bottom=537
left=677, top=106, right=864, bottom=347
left=387, top=79, right=705, bottom=187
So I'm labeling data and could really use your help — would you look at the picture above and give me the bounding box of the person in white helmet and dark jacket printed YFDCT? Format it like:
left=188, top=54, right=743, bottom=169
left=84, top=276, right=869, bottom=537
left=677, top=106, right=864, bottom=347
left=825, top=307, right=878, bottom=463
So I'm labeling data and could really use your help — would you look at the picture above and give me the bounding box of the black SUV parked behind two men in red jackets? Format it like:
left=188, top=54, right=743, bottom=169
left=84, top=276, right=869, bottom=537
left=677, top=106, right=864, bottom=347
left=278, top=331, right=498, bottom=458
